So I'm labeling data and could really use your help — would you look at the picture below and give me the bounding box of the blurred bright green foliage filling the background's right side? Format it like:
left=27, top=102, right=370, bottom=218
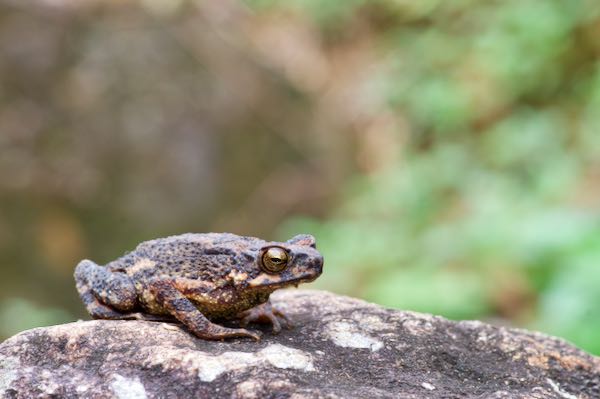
left=261, top=0, right=600, bottom=353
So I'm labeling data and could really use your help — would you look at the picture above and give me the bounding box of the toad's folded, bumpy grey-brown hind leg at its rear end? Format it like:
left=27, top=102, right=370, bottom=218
left=75, top=259, right=137, bottom=320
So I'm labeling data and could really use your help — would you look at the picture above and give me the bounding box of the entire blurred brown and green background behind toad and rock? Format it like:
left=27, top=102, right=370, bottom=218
left=0, top=0, right=600, bottom=354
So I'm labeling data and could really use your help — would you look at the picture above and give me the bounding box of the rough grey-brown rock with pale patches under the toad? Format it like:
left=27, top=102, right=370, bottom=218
left=0, top=290, right=600, bottom=399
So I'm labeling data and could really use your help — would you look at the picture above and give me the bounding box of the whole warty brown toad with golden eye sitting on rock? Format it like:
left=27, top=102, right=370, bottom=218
left=75, top=233, right=323, bottom=339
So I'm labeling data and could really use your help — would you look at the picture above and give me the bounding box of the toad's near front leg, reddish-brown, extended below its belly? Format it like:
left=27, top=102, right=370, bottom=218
left=149, top=280, right=260, bottom=341
